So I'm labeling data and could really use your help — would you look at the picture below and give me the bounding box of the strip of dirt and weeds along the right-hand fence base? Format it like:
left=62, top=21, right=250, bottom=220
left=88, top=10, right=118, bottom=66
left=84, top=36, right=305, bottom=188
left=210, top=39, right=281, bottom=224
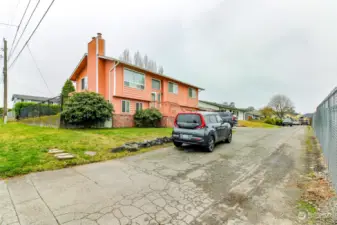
left=297, top=127, right=337, bottom=225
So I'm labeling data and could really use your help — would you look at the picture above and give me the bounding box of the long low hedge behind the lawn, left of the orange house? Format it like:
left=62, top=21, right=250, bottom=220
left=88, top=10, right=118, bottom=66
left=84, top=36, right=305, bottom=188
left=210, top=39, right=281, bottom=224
left=13, top=102, right=60, bottom=119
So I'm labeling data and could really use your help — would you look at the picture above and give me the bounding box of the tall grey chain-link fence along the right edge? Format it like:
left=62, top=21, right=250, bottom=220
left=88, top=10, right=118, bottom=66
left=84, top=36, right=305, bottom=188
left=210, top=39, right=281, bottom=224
left=312, top=87, right=337, bottom=190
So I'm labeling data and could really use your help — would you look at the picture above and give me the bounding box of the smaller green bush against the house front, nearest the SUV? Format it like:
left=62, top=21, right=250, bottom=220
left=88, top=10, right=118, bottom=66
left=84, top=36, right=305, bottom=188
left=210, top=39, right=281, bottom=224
left=134, top=108, right=163, bottom=127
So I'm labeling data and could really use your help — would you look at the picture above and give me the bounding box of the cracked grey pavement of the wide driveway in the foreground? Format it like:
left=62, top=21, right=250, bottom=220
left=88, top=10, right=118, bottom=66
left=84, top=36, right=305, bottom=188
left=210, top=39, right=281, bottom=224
left=0, top=127, right=305, bottom=225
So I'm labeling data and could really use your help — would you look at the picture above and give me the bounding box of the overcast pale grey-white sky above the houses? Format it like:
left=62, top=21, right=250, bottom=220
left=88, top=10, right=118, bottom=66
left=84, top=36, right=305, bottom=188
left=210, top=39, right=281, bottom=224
left=0, top=0, right=337, bottom=113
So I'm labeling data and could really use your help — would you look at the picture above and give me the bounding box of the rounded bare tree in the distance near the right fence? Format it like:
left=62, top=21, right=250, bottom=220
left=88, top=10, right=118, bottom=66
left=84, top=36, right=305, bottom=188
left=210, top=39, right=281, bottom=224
left=268, top=95, right=294, bottom=119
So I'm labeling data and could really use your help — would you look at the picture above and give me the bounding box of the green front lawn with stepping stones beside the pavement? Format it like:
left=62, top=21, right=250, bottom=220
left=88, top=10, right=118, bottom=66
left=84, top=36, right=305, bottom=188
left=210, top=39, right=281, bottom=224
left=0, top=122, right=172, bottom=178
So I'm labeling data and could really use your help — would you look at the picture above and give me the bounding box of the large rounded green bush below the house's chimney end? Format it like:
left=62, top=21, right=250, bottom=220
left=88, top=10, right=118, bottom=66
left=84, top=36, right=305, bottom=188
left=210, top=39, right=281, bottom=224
left=61, top=92, right=114, bottom=127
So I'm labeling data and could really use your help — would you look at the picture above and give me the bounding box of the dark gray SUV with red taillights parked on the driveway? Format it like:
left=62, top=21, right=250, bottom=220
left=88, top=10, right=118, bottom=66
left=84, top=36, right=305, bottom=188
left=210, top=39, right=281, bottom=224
left=172, top=112, right=232, bottom=152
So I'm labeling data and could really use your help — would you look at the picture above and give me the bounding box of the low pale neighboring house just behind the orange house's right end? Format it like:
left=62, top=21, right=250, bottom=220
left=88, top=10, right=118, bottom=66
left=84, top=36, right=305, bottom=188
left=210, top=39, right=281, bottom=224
left=198, top=100, right=246, bottom=120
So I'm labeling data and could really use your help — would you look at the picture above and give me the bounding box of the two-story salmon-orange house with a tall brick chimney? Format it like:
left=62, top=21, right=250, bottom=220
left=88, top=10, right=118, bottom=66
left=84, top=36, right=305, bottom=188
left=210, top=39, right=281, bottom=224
left=70, top=33, right=203, bottom=127
